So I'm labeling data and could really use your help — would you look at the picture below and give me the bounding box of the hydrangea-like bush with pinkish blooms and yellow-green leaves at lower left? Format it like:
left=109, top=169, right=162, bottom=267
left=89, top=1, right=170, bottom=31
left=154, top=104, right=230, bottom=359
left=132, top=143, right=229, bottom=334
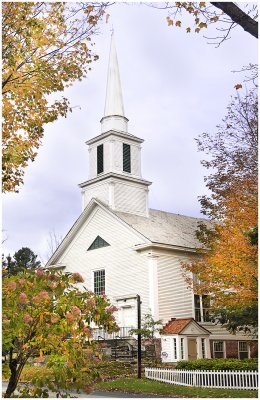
left=2, top=268, right=117, bottom=397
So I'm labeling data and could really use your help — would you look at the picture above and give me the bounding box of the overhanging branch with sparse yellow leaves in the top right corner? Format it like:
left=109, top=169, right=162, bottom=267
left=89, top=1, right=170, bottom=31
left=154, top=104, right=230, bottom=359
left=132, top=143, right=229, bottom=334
left=146, top=2, right=258, bottom=46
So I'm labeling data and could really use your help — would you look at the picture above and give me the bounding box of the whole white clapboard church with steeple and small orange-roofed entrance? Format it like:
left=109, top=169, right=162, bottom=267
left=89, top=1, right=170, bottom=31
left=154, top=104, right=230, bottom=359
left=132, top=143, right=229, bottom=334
left=46, top=34, right=256, bottom=362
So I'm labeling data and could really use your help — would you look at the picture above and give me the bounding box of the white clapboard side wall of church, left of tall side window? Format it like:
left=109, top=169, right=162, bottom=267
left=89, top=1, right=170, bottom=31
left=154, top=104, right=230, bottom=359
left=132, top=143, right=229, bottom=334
left=158, top=253, right=192, bottom=322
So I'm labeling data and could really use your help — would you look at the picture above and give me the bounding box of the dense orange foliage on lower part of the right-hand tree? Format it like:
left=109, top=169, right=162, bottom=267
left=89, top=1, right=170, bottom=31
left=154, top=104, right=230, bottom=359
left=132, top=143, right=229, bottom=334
left=184, top=180, right=258, bottom=307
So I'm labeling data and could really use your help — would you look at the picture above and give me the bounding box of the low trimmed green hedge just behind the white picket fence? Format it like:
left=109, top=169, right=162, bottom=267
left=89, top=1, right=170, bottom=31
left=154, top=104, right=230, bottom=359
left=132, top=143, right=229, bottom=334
left=176, top=358, right=258, bottom=371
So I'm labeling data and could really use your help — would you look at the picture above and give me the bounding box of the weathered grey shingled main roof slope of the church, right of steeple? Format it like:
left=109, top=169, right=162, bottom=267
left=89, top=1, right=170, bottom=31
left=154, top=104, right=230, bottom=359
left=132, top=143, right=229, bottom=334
left=113, top=209, right=210, bottom=249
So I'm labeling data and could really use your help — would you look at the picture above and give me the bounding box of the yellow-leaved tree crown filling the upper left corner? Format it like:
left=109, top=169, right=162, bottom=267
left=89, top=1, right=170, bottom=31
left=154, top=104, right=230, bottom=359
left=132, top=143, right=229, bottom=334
left=2, top=2, right=106, bottom=192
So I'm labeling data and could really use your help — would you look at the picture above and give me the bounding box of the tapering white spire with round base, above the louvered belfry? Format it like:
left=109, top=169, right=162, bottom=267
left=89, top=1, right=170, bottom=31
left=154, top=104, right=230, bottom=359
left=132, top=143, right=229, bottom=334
left=100, top=31, right=128, bottom=132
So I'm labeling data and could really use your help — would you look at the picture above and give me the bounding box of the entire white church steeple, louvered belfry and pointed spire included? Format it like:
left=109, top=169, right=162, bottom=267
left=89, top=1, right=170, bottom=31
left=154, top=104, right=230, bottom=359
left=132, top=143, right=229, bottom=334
left=79, top=33, right=151, bottom=216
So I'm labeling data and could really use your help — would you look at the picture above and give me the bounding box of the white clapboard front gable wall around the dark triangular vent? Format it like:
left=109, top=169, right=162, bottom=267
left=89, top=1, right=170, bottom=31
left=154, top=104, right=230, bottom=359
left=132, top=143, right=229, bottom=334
left=59, top=207, right=149, bottom=313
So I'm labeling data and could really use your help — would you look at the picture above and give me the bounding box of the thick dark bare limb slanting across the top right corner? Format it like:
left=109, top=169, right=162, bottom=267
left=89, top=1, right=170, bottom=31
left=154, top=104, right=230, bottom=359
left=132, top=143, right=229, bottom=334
left=211, top=1, right=258, bottom=38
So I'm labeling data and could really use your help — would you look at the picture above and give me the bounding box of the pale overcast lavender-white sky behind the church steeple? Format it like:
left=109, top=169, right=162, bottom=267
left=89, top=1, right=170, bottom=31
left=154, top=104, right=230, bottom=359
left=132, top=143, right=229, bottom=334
left=3, top=4, right=257, bottom=261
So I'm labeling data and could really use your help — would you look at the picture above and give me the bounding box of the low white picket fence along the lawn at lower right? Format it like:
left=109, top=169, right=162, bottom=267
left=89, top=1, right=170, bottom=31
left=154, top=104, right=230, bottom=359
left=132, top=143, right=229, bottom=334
left=145, top=368, right=258, bottom=390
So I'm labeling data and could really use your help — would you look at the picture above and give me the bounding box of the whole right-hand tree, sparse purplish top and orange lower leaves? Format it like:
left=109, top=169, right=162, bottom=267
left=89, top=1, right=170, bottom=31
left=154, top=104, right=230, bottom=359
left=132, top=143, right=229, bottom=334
left=184, top=90, right=258, bottom=330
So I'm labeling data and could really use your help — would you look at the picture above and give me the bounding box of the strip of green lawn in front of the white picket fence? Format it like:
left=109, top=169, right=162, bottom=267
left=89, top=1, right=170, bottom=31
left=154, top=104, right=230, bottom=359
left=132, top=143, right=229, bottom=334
left=95, top=378, right=257, bottom=398
